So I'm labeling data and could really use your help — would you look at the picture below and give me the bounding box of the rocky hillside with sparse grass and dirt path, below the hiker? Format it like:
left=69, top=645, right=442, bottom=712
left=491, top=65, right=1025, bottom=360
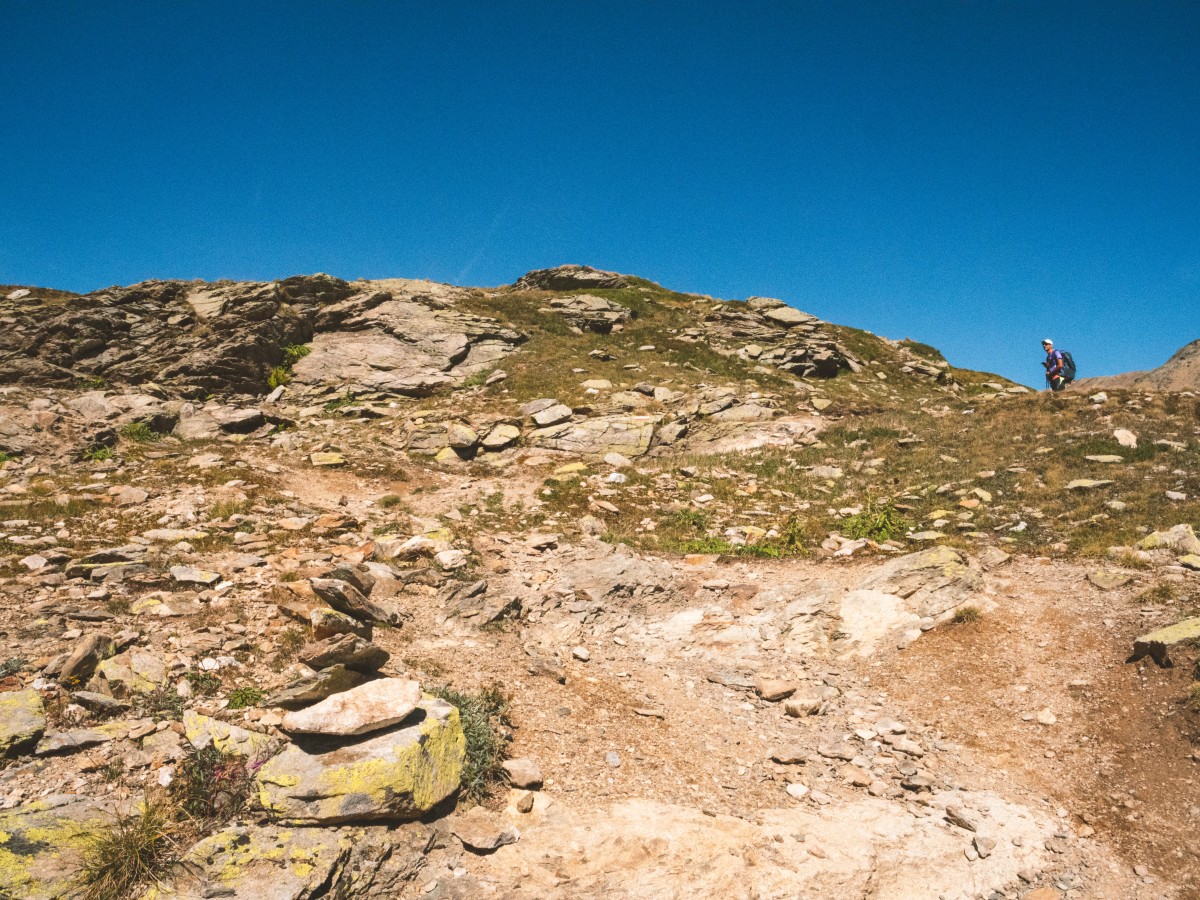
left=0, top=265, right=1200, bottom=900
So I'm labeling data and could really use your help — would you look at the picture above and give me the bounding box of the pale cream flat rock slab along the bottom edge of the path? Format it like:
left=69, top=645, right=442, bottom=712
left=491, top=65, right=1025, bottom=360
left=458, top=791, right=1055, bottom=900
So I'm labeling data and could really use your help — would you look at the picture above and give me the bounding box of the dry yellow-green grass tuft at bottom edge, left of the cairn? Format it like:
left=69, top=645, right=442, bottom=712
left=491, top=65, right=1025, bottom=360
left=76, top=797, right=180, bottom=900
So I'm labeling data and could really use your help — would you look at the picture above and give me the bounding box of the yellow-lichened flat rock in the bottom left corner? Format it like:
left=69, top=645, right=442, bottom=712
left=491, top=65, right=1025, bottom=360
left=0, top=794, right=113, bottom=900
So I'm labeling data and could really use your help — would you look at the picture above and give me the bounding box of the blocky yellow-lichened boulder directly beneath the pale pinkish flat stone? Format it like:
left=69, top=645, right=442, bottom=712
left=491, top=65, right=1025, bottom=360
left=257, top=698, right=467, bottom=824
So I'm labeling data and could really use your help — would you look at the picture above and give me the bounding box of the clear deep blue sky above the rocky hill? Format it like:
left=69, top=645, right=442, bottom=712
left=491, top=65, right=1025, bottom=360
left=0, top=0, right=1200, bottom=384
